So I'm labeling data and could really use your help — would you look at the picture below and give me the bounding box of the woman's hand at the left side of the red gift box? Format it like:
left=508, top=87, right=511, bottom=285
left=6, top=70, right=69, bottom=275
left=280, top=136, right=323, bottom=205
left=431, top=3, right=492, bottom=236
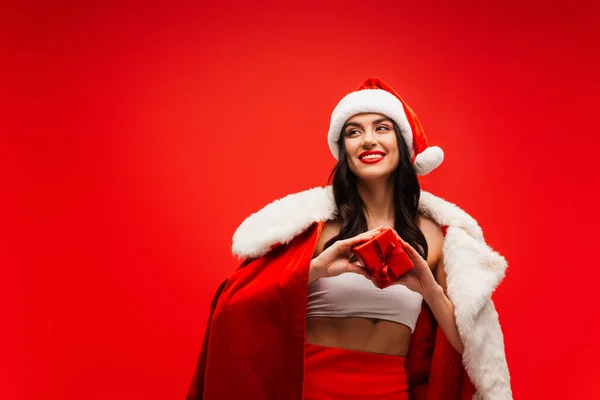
left=308, top=226, right=384, bottom=283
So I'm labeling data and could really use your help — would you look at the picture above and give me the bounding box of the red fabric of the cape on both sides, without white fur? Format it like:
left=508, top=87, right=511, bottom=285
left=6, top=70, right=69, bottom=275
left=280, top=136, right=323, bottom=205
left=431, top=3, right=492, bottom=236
left=187, top=222, right=475, bottom=400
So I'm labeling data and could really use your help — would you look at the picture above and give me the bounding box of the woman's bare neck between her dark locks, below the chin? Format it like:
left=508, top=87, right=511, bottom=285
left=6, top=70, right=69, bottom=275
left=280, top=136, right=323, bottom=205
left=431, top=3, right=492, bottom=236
left=356, top=176, right=395, bottom=229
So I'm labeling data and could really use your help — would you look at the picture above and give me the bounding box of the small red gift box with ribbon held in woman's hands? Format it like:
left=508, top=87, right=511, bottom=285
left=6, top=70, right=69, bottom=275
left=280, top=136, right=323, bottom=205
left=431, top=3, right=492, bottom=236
left=352, top=228, right=414, bottom=289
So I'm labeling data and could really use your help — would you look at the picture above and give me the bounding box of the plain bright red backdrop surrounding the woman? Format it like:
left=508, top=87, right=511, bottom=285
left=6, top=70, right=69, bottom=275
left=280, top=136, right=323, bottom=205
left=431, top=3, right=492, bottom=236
left=0, top=0, right=600, bottom=400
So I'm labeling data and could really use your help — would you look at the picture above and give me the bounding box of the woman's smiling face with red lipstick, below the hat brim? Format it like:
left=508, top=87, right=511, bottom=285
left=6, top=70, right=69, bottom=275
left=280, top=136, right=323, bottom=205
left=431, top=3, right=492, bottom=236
left=342, top=113, right=400, bottom=180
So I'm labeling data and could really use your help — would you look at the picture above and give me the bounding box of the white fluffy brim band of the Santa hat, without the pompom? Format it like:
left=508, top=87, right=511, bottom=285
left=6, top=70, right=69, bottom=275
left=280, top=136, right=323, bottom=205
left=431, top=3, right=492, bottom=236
left=327, top=89, right=414, bottom=159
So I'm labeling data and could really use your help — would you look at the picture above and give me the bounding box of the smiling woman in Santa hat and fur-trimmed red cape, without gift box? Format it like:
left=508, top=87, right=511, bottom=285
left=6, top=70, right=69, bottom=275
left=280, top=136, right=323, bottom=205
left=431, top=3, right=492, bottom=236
left=188, top=78, right=512, bottom=400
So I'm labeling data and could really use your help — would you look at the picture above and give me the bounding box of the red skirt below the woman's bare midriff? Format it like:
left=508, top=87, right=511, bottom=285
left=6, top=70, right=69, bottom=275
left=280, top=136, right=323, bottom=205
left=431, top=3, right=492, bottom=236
left=304, top=343, right=408, bottom=400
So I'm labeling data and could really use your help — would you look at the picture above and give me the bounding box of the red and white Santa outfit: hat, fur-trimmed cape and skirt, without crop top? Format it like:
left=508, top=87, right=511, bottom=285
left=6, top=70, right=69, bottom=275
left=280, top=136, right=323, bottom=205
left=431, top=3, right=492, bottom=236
left=187, top=78, right=512, bottom=400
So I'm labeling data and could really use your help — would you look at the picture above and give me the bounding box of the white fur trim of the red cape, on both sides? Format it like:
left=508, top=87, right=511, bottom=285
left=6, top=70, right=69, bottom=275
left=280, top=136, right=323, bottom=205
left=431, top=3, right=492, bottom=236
left=233, top=186, right=512, bottom=400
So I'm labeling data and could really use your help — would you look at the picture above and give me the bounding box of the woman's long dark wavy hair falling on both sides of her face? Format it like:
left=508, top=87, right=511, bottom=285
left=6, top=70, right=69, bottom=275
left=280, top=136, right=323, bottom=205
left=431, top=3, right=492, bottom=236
left=324, top=121, right=429, bottom=259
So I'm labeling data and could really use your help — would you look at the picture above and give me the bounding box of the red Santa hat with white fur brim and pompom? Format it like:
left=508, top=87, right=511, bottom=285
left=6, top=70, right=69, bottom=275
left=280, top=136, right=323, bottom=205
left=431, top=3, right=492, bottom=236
left=327, top=78, right=444, bottom=175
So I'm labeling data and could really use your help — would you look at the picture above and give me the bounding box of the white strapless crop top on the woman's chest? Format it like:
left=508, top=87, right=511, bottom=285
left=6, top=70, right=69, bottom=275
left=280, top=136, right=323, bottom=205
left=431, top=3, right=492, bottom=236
left=306, top=272, right=423, bottom=332
